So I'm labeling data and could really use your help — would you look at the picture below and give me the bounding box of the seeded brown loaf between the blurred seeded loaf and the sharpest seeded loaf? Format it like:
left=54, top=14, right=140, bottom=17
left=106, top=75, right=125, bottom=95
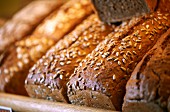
left=25, top=14, right=115, bottom=102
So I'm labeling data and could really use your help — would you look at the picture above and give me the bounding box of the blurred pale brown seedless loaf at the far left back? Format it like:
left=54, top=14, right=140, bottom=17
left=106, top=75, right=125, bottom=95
left=0, top=0, right=65, bottom=52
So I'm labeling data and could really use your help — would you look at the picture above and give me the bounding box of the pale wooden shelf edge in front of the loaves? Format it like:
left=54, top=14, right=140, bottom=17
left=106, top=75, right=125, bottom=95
left=0, top=93, right=114, bottom=112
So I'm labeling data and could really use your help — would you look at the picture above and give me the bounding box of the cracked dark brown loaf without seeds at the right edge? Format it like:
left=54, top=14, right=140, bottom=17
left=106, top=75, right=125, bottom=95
left=123, top=29, right=170, bottom=112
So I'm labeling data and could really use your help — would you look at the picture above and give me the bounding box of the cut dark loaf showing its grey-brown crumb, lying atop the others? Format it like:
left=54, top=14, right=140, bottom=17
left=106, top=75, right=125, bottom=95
left=91, top=0, right=157, bottom=23
